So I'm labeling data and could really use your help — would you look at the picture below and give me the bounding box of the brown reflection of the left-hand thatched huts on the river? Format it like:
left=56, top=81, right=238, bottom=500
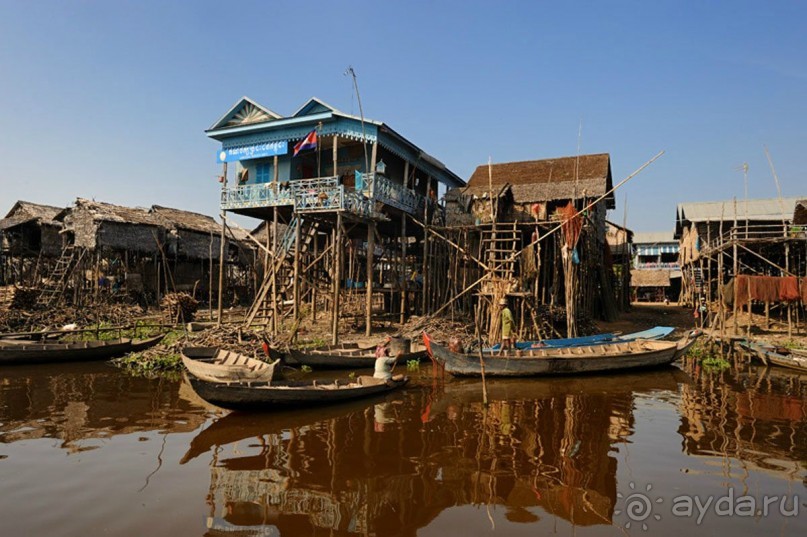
left=0, top=363, right=206, bottom=453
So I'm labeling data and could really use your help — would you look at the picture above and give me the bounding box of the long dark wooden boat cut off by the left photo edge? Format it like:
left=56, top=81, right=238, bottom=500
left=0, top=334, right=164, bottom=364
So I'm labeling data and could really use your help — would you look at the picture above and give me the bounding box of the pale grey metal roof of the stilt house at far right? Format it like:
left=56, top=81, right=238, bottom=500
left=677, top=198, right=799, bottom=222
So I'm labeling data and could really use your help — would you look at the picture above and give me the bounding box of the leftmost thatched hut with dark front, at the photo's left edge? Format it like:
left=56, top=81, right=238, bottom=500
left=0, top=200, right=62, bottom=285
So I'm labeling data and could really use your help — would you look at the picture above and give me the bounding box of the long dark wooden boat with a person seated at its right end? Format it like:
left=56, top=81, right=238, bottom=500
left=186, top=374, right=409, bottom=411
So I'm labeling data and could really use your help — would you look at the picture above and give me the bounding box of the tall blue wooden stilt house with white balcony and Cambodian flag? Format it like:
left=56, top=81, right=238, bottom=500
left=205, top=93, right=464, bottom=340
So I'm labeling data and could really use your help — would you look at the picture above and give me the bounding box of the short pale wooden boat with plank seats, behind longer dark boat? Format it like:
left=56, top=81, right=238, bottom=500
left=180, top=347, right=280, bottom=382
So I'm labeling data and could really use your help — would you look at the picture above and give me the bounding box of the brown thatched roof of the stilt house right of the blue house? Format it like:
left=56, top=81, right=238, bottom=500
left=463, top=153, right=615, bottom=209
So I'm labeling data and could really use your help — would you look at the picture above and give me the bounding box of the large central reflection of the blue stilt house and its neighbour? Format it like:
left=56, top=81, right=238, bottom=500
left=194, top=369, right=688, bottom=535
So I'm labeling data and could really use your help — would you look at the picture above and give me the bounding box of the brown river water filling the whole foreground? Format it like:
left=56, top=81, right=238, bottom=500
left=0, top=361, right=807, bottom=537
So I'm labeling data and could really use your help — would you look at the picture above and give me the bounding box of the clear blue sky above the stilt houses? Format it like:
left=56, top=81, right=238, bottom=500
left=0, top=0, right=807, bottom=231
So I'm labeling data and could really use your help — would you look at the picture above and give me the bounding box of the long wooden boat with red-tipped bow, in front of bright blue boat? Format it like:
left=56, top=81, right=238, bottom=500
left=423, top=331, right=701, bottom=377
